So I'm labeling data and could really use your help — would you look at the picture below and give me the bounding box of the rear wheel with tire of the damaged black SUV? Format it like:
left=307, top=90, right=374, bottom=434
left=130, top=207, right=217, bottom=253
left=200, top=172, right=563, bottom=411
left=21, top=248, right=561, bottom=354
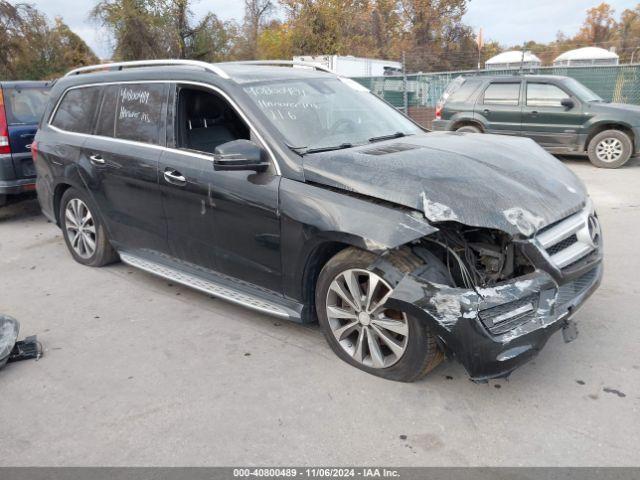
left=59, top=188, right=118, bottom=267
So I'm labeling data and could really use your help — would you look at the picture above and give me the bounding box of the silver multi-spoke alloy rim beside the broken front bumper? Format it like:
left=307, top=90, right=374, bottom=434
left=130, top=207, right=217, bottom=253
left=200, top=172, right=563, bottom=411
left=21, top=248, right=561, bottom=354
left=326, top=269, right=409, bottom=368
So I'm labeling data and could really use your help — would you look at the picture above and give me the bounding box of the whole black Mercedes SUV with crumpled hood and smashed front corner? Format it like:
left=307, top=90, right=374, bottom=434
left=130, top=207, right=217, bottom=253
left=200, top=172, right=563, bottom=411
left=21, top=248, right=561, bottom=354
left=34, top=61, right=602, bottom=381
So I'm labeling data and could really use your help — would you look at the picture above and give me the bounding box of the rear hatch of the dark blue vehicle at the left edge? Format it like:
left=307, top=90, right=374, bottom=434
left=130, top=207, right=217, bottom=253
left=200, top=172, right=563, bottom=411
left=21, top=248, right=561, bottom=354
left=3, top=83, right=49, bottom=180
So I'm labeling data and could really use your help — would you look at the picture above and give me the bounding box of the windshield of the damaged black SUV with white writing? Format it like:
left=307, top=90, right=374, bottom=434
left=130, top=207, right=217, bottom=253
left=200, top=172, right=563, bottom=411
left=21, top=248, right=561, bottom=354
left=244, top=77, right=421, bottom=151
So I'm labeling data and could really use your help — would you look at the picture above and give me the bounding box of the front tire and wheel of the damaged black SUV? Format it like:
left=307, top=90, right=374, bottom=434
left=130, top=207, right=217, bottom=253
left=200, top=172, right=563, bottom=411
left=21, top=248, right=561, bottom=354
left=315, top=248, right=444, bottom=382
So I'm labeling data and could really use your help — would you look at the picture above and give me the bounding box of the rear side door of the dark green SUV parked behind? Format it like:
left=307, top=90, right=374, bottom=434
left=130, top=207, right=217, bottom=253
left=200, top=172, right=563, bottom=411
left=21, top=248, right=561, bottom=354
left=475, top=80, right=522, bottom=135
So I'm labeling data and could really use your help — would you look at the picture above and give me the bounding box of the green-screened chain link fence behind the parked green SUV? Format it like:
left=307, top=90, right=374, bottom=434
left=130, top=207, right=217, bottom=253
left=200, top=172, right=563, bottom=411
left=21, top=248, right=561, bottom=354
left=354, top=64, right=640, bottom=128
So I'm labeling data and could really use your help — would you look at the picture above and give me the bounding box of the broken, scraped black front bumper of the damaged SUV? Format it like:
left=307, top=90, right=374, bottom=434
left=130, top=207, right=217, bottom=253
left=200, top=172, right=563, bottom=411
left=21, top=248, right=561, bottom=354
left=388, top=260, right=603, bottom=380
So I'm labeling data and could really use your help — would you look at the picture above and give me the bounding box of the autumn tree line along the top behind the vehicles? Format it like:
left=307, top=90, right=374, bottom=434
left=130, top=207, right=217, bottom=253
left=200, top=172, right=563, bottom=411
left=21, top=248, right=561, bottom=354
left=0, top=0, right=640, bottom=79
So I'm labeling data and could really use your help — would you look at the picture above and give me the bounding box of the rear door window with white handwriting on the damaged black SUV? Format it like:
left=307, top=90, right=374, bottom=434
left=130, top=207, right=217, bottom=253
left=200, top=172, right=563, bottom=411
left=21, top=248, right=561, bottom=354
left=113, top=83, right=167, bottom=145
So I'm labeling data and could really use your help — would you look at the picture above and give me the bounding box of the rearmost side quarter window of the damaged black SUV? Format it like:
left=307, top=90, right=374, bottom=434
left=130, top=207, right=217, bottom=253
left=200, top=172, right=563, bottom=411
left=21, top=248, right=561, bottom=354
left=51, top=87, right=100, bottom=133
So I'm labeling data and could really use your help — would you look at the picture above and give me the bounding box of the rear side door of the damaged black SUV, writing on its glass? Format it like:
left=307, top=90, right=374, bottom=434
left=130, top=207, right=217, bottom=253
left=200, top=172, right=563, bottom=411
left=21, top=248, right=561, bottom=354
left=79, top=83, right=169, bottom=253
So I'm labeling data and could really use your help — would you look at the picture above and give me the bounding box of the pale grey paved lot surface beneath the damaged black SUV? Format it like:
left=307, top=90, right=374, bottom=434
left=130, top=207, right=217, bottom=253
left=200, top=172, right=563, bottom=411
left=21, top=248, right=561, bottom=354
left=0, top=159, right=640, bottom=466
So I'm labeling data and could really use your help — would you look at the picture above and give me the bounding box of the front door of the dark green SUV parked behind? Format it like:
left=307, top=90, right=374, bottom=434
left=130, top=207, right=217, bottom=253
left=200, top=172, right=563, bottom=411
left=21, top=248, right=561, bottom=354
left=522, top=80, right=586, bottom=150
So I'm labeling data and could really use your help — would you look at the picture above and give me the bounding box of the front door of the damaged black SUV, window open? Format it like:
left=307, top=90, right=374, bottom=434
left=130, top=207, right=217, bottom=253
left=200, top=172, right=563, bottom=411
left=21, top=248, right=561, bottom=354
left=159, top=85, right=282, bottom=292
